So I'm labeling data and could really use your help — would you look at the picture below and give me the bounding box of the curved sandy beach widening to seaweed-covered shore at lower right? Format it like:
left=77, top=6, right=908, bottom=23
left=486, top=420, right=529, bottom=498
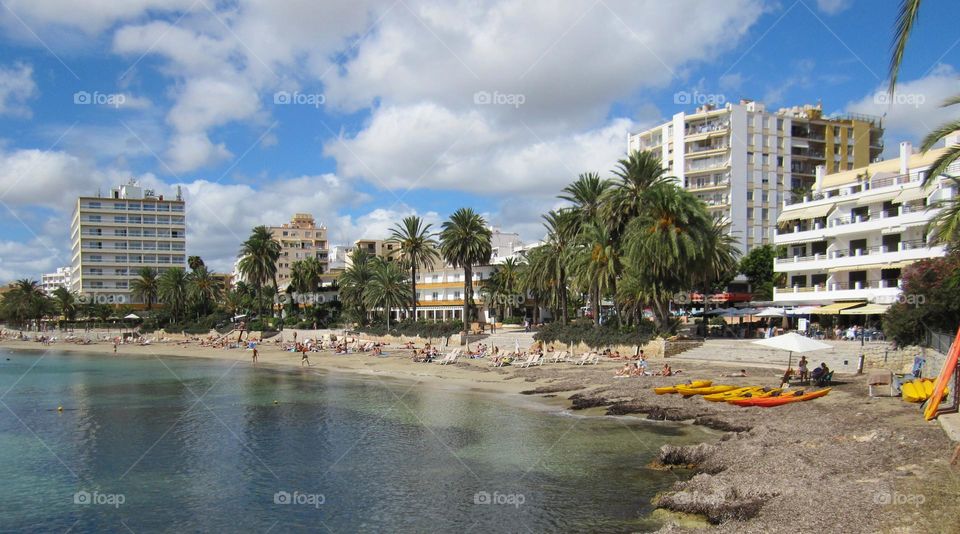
left=0, top=340, right=960, bottom=532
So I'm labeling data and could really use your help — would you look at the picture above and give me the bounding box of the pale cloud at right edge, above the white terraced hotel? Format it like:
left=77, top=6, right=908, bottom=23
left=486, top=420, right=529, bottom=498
left=846, top=65, right=960, bottom=155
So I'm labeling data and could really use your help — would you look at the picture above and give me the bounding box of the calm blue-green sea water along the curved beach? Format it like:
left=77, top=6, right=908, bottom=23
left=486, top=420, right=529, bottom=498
left=0, top=351, right=709, bottom=533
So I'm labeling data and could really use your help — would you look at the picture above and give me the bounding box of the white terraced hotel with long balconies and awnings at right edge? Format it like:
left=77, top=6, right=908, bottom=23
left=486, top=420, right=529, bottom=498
left=774, top=138, right=960, bottom=304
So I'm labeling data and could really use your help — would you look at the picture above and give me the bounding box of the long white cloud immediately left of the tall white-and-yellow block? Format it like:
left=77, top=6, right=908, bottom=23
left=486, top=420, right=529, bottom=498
left=324, top=104, right=634, bottom=196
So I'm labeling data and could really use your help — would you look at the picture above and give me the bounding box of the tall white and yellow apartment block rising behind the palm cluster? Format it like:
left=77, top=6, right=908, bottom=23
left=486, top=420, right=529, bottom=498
left=627, top=100, right=883, bottom=252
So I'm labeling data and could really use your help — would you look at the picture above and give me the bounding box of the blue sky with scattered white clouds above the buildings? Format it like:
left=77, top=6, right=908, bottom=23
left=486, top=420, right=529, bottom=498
left=0, top=0, right=960, bottom=281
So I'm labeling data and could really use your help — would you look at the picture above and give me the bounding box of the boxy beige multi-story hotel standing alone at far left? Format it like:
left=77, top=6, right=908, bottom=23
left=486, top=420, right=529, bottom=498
left=70, top=180, right=187, bottom=304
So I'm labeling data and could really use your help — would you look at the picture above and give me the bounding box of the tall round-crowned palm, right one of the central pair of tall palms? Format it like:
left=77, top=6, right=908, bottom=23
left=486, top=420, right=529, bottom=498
left=440, top=208, right=493, bottom=326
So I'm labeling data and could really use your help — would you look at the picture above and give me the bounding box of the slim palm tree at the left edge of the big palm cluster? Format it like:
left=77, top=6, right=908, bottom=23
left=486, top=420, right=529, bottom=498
left=523, top=209, right=577, bottom=324
